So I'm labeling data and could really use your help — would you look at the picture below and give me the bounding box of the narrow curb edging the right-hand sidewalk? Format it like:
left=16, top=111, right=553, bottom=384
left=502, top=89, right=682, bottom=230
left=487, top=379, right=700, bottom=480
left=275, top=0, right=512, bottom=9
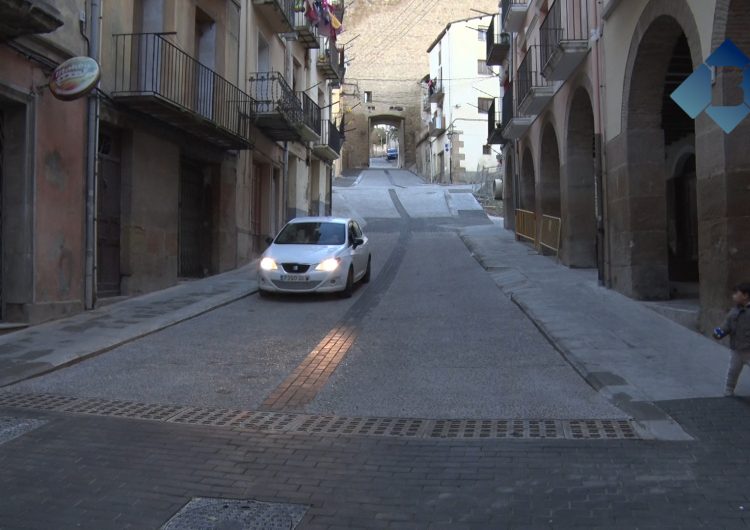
left=459, top=230, right=694, bottom=441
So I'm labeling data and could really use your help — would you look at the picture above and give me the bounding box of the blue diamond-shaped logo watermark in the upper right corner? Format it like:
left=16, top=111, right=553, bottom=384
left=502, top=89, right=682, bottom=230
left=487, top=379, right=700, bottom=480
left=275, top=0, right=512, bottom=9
left=671, top=39, right=750, bottom=134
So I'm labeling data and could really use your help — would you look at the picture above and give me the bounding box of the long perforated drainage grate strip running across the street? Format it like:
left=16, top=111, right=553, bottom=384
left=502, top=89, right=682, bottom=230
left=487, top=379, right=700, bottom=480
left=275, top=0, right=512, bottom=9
left=0, top=393, right=640, bottom=440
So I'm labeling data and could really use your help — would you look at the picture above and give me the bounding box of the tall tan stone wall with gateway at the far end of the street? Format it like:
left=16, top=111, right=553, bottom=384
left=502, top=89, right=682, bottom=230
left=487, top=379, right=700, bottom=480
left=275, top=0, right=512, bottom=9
left=341, top=0, right=497, bottom=169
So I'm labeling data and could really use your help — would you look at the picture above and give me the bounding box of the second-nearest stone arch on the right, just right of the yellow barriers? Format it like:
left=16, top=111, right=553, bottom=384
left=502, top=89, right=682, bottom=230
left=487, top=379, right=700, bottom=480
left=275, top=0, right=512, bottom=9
left=561, top=86, right=597, bottom=267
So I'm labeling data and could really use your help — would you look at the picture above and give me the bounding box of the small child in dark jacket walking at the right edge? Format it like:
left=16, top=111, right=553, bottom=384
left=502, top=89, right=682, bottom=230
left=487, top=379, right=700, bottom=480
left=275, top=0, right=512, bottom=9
left=714, top=283, right=750, bottom=396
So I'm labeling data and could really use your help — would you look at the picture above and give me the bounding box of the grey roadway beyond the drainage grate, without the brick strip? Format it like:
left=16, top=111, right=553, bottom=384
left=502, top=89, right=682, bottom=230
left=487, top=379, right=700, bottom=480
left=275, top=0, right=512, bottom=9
left=4, top=169, right=624, bottom=419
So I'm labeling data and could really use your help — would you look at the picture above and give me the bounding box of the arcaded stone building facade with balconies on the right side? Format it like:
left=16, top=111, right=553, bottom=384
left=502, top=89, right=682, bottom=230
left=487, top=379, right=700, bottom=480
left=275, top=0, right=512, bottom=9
left=499, top=0, right=750, bottom=329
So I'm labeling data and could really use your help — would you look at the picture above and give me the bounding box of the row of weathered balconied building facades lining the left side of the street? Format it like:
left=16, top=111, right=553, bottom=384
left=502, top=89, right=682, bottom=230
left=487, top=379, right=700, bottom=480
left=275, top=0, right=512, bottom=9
left=0, top=0, right=344, bottom=325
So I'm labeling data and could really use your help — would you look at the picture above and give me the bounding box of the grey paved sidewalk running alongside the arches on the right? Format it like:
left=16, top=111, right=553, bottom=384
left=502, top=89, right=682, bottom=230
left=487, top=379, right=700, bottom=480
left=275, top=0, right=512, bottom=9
left=461, top=225, right=750, bottom=438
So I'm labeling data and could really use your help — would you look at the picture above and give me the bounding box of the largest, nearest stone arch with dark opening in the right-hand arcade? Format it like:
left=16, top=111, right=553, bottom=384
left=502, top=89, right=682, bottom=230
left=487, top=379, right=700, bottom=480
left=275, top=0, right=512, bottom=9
left=609, top=0, right=703, bottom=300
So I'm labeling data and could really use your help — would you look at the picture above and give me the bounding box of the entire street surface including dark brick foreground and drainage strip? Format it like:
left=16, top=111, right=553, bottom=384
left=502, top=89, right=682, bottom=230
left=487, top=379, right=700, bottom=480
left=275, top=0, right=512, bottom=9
left=0, top=168, right=750, bottom=528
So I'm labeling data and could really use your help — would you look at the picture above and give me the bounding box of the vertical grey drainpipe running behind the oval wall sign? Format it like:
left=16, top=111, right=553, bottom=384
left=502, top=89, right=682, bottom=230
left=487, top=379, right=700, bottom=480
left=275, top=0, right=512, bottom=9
left=84, top=0, right=102, bottom=309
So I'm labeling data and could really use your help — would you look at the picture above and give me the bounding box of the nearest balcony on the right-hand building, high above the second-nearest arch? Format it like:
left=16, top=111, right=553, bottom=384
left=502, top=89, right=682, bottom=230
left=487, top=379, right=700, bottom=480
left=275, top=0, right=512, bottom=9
left=539, top=0, right=591, bottom=81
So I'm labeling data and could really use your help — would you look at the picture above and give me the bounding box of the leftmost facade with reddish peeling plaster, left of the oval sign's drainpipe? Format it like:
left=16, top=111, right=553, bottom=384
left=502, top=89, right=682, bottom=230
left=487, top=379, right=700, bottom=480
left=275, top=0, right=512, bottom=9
left=0, top=0, right=86, bottom=329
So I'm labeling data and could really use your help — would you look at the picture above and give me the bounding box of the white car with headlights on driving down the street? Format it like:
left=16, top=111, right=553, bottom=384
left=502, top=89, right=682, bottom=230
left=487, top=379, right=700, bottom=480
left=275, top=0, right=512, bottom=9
left=258, top=217, right=372, bottom=298
